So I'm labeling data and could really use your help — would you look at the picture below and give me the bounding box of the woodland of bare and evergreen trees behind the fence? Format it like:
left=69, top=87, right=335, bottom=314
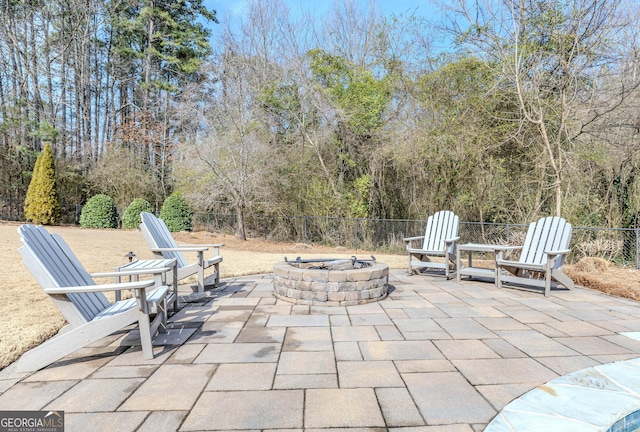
left=0, top=0, right=640, bottom=238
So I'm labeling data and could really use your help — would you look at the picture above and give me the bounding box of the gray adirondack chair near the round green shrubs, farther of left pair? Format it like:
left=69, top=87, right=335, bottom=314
left=140, top=212, right=224, bottom=293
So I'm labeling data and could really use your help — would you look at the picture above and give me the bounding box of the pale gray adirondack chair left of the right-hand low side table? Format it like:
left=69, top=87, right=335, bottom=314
left=404, top=210, right=460, bottom=279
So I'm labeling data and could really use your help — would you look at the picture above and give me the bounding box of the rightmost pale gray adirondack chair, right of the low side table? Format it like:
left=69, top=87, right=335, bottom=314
left=496, top=216, right=574, bottom=296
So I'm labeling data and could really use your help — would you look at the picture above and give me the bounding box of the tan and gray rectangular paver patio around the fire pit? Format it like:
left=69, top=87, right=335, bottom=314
left=0, top=270, right=640, bottom=432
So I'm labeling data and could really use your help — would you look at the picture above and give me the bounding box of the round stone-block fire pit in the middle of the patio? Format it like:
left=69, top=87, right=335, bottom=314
left=273, top=257, right=389, bottom=306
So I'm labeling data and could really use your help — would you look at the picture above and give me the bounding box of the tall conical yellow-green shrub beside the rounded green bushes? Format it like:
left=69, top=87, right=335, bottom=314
left=24, top=143, right=61, bottom=225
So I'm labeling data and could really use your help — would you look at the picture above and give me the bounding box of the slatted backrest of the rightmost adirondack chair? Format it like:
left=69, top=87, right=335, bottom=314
left=519, top=216, right=571, bottom=268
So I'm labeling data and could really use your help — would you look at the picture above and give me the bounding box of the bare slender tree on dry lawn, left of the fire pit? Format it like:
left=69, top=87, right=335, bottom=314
left=176, top=5, right=275, bottom=240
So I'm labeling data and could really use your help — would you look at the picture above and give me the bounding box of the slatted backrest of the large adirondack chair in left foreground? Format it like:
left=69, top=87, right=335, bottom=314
left=18, top=224, right=110, bottom=325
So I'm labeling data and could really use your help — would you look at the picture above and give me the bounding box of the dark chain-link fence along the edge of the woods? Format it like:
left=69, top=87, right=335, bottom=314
left=0, top=198, right=640, bottom=269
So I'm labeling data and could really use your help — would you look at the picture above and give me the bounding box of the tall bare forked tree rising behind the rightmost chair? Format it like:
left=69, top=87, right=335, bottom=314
left=448, top=0, right=640, bottom=215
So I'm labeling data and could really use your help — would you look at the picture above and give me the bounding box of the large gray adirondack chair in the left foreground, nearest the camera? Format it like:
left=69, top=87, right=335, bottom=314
left=16, top=224, right=169, bottom=372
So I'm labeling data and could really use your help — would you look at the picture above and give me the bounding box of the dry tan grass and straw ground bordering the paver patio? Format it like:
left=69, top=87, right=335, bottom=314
left=0, top=222, right=640, bottom=369
